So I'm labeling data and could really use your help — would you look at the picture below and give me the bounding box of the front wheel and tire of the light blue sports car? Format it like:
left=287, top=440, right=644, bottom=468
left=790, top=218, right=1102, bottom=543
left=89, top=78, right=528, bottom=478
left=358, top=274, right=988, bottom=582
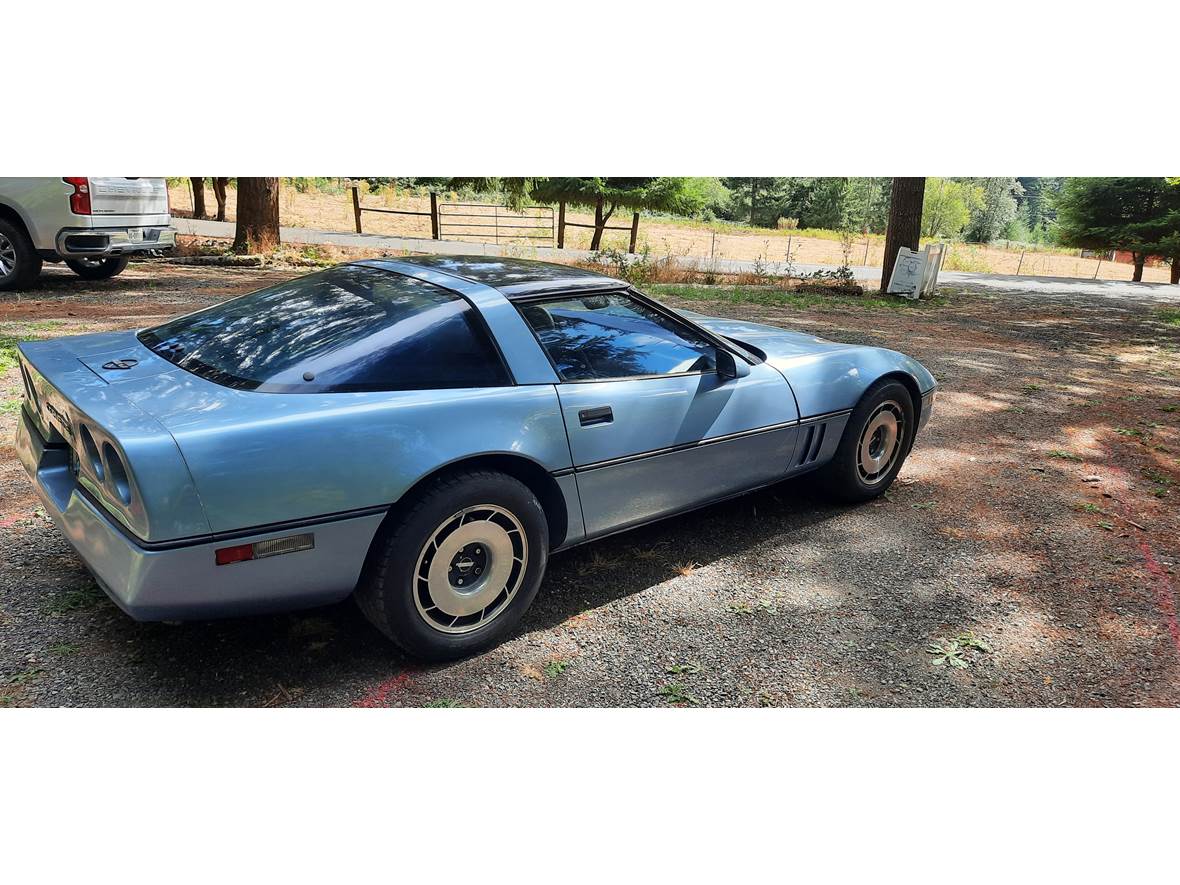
left=815, top=378, right=916, bottom=504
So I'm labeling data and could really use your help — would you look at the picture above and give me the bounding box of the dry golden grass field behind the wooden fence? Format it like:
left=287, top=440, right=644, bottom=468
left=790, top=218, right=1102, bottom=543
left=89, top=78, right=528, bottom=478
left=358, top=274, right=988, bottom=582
left=169, top=185, right=1168, bottom=283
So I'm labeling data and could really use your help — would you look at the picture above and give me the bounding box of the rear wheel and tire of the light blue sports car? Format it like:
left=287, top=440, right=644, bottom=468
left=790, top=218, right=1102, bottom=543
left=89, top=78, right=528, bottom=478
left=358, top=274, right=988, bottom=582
left=356, top=470, right=549, bottom=661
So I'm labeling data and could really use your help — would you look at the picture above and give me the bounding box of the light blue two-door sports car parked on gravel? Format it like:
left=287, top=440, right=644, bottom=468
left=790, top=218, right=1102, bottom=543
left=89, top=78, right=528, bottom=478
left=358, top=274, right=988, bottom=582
left=11, top=256, right=935, bottom=658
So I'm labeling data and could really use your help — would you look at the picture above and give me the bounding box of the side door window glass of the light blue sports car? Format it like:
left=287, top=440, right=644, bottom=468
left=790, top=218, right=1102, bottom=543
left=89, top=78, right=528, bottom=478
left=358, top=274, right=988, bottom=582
left=520, top=293, right=717, bottom=381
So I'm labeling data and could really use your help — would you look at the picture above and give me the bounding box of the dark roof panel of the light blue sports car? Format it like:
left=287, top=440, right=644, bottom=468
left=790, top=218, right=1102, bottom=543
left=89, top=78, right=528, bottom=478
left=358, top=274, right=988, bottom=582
left=367, top=255, right=627, bottom=299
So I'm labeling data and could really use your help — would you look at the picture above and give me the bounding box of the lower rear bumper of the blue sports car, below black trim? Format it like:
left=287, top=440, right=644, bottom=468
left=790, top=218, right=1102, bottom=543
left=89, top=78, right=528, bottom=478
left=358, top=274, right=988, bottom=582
left=17, top=409, right=382, bottom=621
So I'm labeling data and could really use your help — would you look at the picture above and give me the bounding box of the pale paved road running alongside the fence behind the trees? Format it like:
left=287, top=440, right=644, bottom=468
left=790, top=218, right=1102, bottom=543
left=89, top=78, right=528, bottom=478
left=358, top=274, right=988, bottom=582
left=172, top=218, right=1180, bottom=303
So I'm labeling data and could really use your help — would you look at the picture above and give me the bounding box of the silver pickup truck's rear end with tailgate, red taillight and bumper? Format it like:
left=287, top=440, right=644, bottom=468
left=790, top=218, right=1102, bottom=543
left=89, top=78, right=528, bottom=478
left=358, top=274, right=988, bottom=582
left=52, top=177, right=176, bottom=258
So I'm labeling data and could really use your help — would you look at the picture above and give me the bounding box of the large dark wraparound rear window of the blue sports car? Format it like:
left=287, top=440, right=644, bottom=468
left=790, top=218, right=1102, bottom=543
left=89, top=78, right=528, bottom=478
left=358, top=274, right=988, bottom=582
left=139, top=266, right=510, bottom=393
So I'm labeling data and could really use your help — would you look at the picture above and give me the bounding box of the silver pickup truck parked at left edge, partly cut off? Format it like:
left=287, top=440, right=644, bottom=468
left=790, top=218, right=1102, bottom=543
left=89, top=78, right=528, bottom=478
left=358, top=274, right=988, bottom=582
left=0, top=178, right=176, bottom=291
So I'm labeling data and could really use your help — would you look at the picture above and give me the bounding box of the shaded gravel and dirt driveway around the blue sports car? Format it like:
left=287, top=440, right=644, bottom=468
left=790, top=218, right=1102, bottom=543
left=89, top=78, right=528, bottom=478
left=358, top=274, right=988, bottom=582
left=0, top=264, right=1180, bottom=706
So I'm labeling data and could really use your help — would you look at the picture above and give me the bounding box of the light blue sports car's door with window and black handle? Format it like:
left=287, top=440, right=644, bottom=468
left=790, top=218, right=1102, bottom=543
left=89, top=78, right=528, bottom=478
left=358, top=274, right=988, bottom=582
left=520, top=291, right=799, bottom=535
